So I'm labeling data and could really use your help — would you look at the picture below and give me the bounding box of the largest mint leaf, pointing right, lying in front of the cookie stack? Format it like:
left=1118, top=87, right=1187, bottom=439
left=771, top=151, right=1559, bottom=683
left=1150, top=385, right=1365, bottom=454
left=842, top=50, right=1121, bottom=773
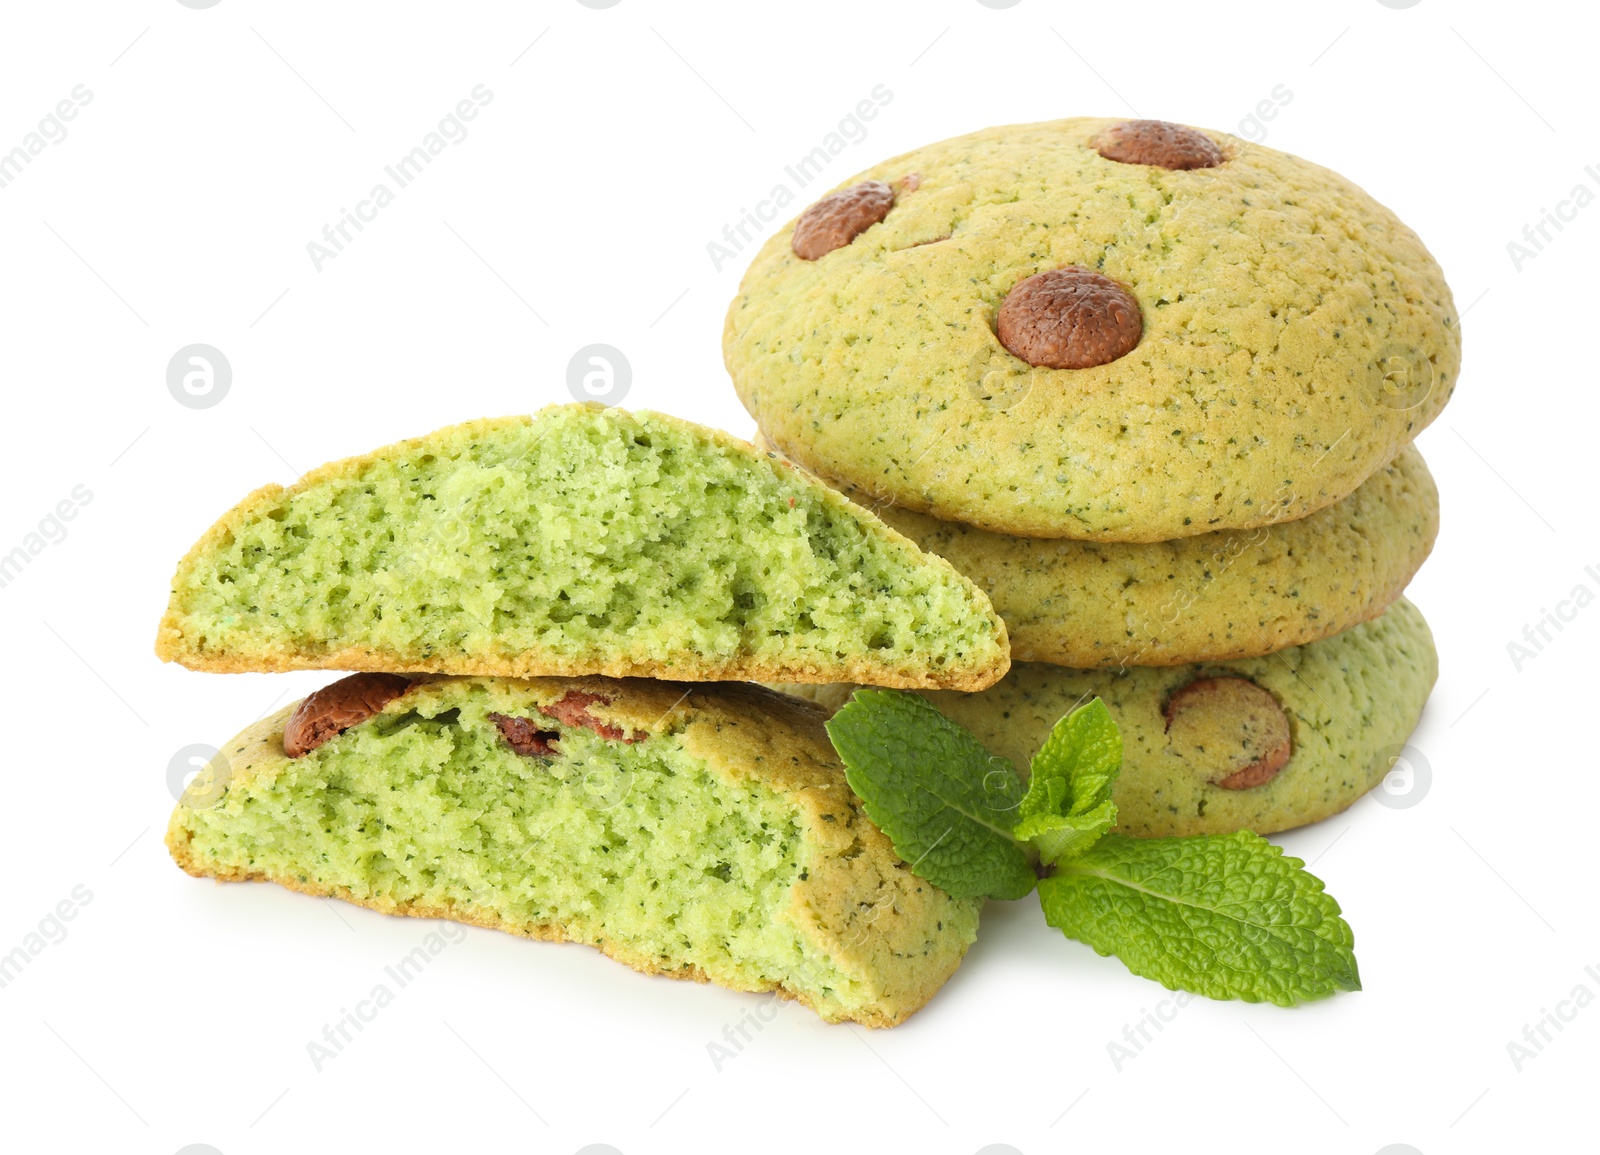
left=1038, top=830, right=1362, bottom=1006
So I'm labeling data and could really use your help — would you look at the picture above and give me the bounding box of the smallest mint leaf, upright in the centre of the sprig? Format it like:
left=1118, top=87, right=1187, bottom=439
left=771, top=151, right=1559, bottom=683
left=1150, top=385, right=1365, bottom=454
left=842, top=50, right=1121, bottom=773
left=1013, top=697, right=1122, bottom=865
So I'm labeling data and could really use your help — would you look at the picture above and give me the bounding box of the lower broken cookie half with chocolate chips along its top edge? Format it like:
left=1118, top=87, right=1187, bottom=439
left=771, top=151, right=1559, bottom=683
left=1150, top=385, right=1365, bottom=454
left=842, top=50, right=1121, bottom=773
left=166, top=673, right=981, bottom=1025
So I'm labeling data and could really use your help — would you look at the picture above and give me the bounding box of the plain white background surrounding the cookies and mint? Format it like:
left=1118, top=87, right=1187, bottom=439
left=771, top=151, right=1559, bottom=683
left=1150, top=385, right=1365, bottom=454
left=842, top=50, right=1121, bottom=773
left=0, top=0, right=1600, bottom=1155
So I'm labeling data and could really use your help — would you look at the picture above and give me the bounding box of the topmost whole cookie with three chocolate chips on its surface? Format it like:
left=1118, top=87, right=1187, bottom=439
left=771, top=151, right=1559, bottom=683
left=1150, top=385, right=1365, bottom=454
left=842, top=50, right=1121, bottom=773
left=723, top=118, right=1461, bottom=542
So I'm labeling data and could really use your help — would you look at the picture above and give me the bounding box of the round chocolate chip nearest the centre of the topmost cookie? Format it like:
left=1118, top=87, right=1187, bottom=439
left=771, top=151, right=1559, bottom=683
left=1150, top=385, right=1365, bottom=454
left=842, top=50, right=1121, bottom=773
left=995, top=264, right=1144, bottom=370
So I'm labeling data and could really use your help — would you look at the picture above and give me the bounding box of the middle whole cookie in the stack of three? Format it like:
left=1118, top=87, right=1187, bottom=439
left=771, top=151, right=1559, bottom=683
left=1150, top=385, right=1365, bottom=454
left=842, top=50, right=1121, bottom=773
left=875, top=445, right=1438, bottom=667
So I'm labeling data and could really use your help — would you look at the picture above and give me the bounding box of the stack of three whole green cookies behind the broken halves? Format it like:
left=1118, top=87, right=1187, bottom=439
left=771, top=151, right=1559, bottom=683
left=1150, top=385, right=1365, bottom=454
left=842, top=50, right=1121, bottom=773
left=723, top=120, right=1461, bottom=835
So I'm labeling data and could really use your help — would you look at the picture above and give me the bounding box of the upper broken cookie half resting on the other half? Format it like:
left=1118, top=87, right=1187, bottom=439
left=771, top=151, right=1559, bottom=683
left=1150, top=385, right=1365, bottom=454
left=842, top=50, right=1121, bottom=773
left=155, top=403, right=1010, bottom=689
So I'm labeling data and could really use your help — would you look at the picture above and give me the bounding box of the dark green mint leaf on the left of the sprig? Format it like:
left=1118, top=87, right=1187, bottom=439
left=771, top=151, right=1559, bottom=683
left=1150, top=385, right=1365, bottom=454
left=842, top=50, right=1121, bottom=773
left=827, top=689, right=1037, bottom=899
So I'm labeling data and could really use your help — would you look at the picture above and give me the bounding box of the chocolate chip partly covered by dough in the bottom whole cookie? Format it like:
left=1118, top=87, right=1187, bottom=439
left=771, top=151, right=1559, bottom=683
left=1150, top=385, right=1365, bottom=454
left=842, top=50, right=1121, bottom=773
left=1165, top=677, right=1294, bottom=790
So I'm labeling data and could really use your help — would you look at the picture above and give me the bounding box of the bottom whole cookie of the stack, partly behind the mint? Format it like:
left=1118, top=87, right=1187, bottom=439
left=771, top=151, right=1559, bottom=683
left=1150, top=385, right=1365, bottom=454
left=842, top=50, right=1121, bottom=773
left=784, top=598, right=1438, bottom=838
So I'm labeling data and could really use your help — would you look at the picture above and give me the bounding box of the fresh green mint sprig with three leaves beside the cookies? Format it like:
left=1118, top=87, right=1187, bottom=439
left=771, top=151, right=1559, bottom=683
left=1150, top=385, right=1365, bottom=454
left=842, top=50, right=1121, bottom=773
left=827, top=691, right=1362, bottom=1006
